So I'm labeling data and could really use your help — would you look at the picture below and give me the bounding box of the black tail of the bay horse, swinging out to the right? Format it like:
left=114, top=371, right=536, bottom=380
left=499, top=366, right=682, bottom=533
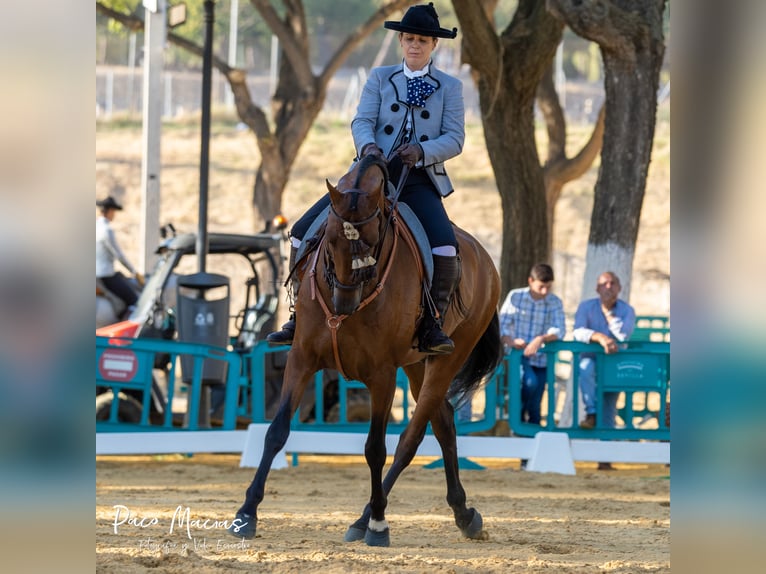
left=447, top=311, right=503, bottom=408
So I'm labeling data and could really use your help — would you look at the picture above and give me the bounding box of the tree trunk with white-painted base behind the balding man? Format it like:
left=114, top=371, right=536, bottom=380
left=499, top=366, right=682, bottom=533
left=549, top=0, right=667, bottom=300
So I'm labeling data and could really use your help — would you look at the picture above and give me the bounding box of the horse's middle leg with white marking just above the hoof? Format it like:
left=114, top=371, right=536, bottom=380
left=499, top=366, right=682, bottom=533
left=343, top=373, right=396, bottom=546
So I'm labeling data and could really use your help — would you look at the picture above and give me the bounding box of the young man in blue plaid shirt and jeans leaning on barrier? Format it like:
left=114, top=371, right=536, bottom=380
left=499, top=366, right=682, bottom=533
left=500, top=263, right=566, bottom=425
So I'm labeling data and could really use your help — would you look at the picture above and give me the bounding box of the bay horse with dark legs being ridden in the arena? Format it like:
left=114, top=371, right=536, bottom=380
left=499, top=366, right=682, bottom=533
left=229, top=156, right=502, bottom=546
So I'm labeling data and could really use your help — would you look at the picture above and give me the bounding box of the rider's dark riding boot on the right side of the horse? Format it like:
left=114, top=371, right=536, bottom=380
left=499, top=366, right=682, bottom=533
left=418, top=255, right=460, bottom=355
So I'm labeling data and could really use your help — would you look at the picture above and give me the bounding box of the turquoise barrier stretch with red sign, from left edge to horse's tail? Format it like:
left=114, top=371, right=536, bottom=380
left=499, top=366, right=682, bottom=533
left=96, top=337, right=499, bottom=434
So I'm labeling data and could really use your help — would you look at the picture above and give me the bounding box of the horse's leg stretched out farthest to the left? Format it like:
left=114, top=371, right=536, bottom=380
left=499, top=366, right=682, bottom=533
left=228, top=361, right=312, bottom=539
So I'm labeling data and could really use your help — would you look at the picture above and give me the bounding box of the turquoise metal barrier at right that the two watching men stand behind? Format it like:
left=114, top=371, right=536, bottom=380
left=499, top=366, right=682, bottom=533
left=505, top=341, right=670, bottom=441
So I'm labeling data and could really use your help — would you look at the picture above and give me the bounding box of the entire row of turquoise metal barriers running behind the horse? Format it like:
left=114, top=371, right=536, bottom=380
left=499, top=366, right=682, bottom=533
left=96, top=337, right=670, bottom=448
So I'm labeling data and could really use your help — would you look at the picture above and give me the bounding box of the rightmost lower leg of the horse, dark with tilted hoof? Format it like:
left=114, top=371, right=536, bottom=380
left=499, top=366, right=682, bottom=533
left=431, top=400, right=489, bottom=540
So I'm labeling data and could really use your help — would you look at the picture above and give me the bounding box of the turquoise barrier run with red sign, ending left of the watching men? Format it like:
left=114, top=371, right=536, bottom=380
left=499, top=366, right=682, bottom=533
left=96, top=337, right=504, bottom=434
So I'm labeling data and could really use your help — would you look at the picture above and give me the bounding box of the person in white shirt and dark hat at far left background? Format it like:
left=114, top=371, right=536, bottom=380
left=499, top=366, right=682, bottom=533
left=96, top=196, right=144, bottom=316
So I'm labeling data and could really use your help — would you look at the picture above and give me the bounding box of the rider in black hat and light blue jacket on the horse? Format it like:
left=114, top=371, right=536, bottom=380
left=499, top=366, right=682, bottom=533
left=267, top=3, right=465, bottom=355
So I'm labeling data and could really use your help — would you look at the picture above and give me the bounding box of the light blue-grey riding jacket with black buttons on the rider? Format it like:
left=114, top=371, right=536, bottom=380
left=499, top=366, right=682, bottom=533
left=351, top=63, right=465, bottom=197
